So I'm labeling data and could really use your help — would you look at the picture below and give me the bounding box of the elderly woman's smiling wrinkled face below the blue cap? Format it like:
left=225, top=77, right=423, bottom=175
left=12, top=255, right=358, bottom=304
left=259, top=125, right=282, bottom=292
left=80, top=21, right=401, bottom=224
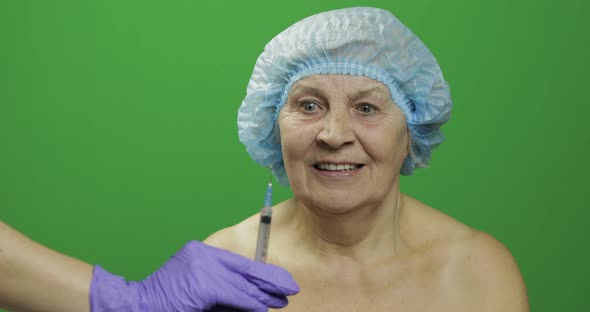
left=278, top=75, right=408, bottom=213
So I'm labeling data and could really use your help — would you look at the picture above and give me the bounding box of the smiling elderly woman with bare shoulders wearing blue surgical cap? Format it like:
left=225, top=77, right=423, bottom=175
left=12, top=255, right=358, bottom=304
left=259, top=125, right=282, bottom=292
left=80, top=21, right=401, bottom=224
left=206, top=8, right=528, bottom=312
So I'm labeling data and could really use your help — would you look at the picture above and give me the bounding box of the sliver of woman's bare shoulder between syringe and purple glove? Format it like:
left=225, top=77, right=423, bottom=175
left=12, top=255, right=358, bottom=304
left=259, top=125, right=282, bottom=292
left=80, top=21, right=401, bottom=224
left=203, top=214, right=259, bottom=258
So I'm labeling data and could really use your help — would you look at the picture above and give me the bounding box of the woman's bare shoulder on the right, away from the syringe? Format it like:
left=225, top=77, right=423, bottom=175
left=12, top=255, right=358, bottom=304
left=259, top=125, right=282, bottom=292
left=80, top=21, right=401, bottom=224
left=404, top=196, right=529, bottom=312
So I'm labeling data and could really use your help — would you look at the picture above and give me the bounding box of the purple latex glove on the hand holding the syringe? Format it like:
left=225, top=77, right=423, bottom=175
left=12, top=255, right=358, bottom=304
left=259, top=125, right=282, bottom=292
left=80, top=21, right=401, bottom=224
left=90, top=241, right=299, bottom=312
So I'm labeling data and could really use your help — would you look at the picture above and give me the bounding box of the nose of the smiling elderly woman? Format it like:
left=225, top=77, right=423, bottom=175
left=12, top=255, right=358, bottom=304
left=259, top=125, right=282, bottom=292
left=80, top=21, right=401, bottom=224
left=317, top=111, right=355, bottom=149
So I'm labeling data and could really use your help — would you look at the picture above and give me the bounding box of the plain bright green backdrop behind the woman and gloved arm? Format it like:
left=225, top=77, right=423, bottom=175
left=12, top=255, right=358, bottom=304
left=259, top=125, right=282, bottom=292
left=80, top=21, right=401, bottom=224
left=0, top=0, right=590, bottom=311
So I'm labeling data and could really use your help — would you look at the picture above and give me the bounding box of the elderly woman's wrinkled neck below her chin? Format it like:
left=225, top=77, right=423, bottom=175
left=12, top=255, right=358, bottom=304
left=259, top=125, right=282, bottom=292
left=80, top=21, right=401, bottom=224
left=291, top=181, right=404, bottom=262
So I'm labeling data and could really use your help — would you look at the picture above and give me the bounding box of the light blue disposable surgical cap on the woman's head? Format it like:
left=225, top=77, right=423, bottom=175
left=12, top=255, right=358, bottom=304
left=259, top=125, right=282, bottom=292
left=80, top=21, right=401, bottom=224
left=238, top=7, right=452, bottom=185
